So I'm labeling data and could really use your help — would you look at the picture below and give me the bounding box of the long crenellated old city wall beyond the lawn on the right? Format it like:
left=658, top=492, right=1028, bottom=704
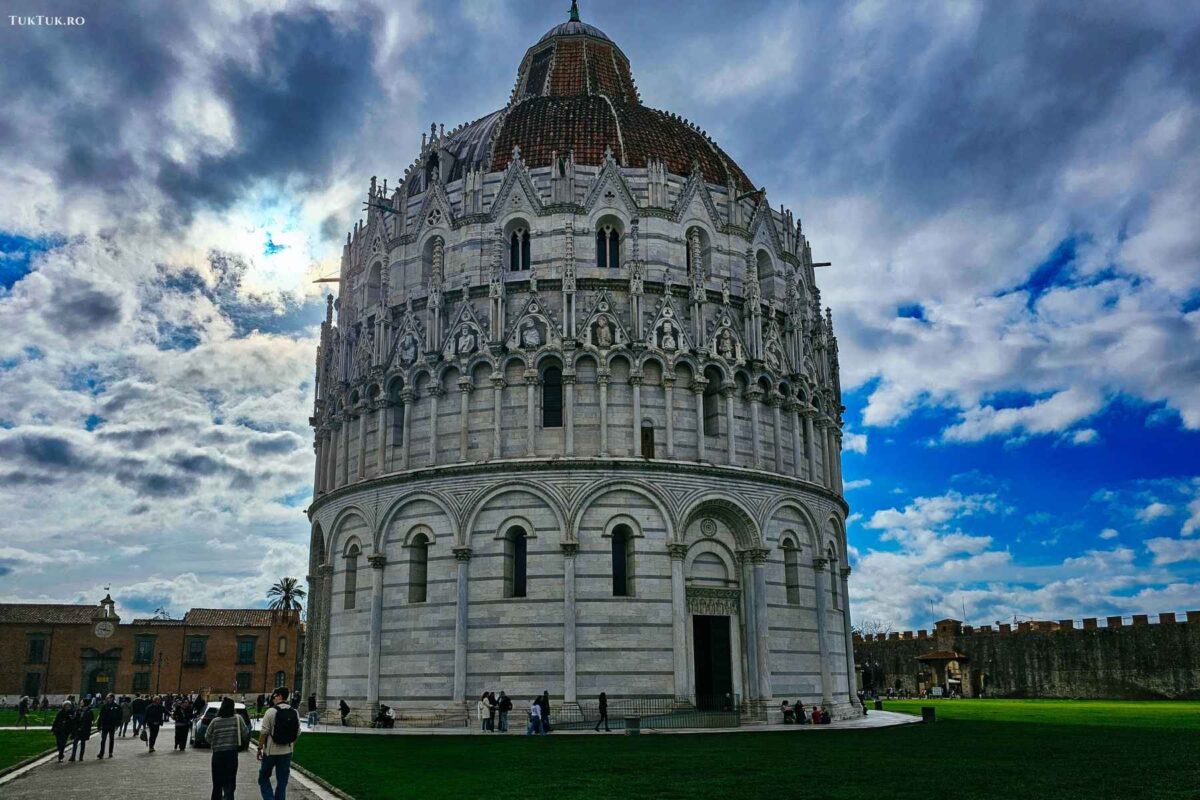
left=854, top=612, right=1200, bottom=699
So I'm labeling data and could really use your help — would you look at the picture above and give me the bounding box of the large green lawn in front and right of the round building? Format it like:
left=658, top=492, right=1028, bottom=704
left=296, top=700, right=1200, bottom=800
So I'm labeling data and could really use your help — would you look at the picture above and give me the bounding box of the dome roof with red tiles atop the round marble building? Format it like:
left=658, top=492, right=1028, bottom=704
left=444, top=8, right=754, bottom=191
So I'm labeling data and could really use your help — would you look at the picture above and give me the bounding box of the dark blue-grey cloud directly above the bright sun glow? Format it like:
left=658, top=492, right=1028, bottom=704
left=158, top=11, right=378, bottom=210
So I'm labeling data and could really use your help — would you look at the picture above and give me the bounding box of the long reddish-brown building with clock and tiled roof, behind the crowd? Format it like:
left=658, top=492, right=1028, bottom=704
left=0, top=596, right=302, bottom=700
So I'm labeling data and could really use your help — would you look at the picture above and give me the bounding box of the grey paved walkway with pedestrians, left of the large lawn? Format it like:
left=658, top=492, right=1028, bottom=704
left=0, top=730, right=332, bottom=800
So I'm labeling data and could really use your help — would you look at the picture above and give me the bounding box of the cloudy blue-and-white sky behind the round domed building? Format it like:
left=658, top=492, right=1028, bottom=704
left=0, top=0, right=1200, bottom=627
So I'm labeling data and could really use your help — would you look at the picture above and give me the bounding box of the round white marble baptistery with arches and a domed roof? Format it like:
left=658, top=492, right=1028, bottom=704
left=305, top=8, right=857, bottom=716
